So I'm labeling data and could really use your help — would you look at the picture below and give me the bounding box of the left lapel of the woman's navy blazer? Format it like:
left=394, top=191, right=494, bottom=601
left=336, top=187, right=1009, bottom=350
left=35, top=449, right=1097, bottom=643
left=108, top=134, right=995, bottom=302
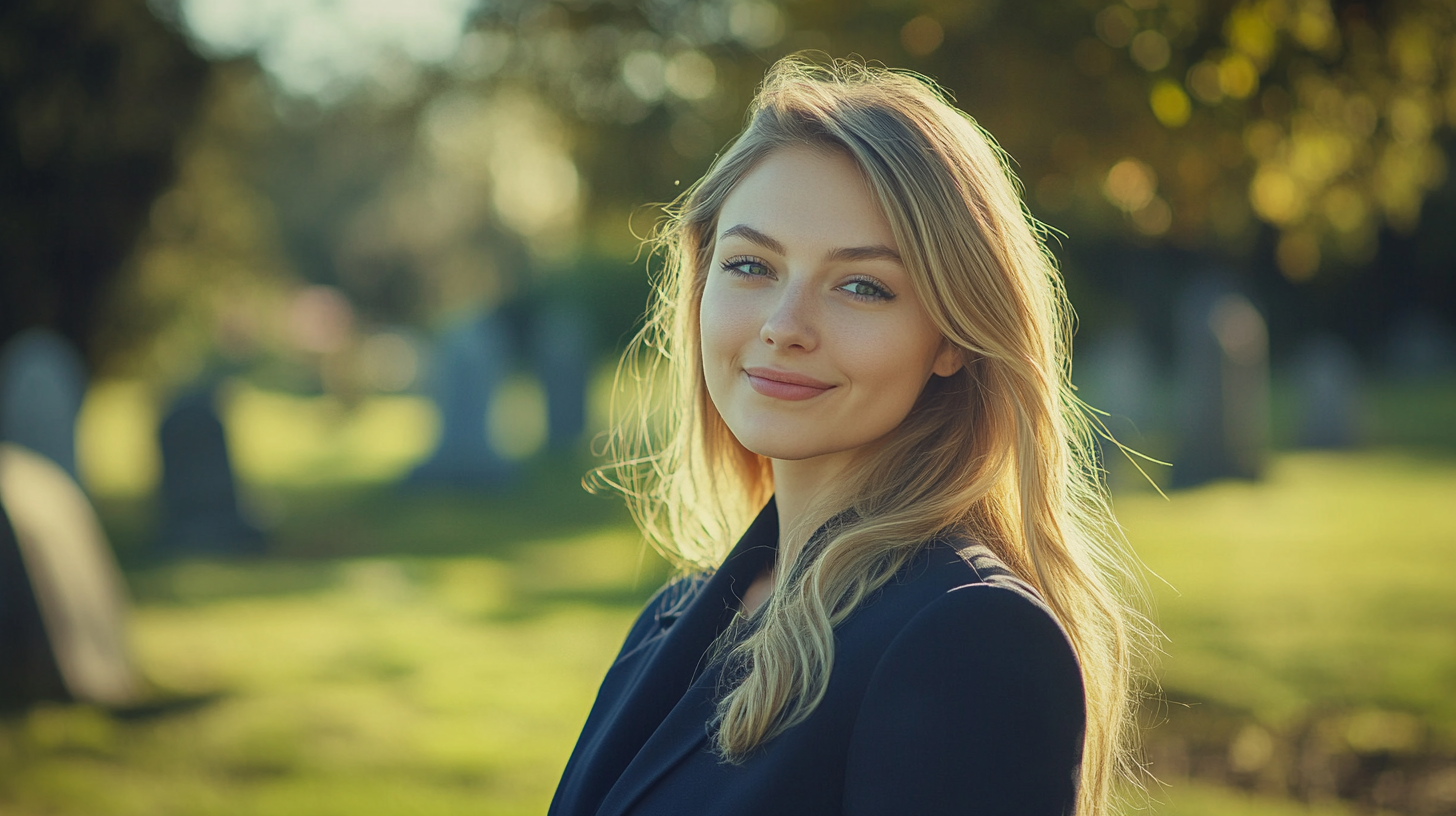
left=567, top=500, right=779, bottom=816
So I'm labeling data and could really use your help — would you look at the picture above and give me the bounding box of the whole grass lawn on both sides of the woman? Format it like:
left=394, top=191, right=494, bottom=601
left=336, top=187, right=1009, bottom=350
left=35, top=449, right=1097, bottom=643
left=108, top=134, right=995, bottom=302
left=0, top=453, right=1456, bottom=816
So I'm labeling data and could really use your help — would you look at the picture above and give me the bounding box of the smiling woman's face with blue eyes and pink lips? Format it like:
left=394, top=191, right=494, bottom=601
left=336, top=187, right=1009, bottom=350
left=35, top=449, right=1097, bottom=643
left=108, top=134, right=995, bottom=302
left=700, top=147, right=960, bottom=460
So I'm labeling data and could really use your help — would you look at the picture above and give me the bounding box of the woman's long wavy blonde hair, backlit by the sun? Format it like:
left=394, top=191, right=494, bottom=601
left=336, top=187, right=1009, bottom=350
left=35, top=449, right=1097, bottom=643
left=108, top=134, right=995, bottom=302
left=597, top=57, right=1150, bottom=816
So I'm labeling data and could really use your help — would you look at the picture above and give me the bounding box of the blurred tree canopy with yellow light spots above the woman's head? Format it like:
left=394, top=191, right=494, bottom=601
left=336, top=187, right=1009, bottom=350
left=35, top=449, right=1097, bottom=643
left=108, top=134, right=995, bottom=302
left=445, top=0, right=1456, bottom=280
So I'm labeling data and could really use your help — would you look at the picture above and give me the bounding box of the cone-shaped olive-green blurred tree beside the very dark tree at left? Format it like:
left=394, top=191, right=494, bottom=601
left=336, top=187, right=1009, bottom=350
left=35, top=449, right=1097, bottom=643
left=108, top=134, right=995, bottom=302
left=96, top=64, right=297, bottom=383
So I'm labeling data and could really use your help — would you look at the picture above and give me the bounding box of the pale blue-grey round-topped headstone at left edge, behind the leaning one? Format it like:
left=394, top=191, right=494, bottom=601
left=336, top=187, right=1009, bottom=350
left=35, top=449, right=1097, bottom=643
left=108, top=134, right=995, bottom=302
left=0, top=329, right=86, bottom=479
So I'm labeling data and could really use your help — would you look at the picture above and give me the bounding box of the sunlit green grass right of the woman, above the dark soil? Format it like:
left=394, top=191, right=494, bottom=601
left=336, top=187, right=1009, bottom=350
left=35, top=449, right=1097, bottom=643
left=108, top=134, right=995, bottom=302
left=1117, top=453, right=1456, bottom=745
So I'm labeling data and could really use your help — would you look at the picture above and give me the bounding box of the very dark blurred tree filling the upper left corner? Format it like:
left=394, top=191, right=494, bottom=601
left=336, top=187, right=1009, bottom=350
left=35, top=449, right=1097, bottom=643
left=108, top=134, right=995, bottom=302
left=0, top=0, right=208, bottom=361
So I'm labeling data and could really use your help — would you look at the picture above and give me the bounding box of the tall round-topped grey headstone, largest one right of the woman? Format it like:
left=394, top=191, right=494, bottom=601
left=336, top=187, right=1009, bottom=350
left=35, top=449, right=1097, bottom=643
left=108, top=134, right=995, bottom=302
left=1172, top=278, right=1270, bottom=487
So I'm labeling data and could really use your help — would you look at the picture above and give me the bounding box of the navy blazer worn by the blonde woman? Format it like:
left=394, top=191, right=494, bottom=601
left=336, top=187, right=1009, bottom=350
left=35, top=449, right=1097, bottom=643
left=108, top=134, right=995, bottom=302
left=550, top=501, right=1085, bottom=816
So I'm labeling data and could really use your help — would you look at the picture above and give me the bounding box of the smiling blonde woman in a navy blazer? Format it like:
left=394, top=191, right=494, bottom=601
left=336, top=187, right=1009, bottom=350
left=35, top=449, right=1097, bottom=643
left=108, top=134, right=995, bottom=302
left=552, top=58, right=1142, bottom=816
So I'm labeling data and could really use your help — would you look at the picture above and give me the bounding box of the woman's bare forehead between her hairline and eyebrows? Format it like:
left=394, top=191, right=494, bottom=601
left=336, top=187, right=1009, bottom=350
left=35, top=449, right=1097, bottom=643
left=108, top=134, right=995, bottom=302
left=718, top=147, right=898, bottom=254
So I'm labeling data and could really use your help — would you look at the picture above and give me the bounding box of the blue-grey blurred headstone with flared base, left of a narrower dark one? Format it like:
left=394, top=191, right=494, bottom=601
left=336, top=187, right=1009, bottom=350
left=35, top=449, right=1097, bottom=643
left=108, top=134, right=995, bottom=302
left=409, top=315, right=511, bottom=485
